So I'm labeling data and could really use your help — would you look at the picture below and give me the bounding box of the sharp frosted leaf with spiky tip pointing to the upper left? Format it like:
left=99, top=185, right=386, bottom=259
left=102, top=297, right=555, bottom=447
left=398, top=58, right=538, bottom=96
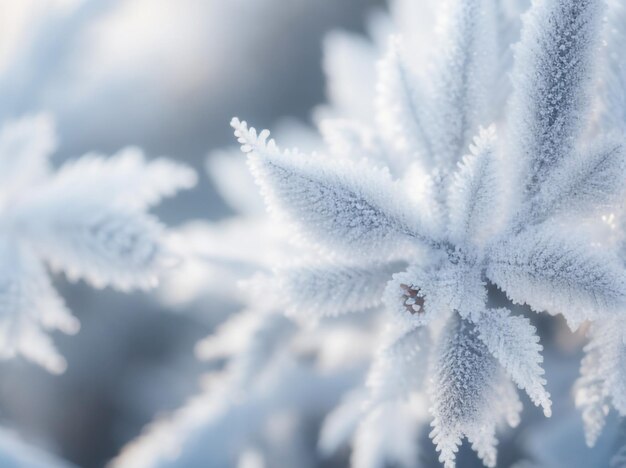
left=232, top=119, right=437, bottom=257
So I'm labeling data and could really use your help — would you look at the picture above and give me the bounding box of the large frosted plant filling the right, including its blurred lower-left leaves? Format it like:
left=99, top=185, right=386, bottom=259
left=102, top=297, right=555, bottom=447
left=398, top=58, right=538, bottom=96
left=114, top=0, right=626, bottom=468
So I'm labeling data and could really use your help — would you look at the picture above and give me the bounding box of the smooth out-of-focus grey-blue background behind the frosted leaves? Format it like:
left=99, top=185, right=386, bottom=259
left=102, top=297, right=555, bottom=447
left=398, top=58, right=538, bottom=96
left=0, top=0, right=383, bottom=467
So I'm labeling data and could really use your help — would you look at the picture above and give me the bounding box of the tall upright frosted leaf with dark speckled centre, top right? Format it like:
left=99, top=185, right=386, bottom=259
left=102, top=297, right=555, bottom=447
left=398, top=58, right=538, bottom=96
left=509, top=0, right=602, bottom=194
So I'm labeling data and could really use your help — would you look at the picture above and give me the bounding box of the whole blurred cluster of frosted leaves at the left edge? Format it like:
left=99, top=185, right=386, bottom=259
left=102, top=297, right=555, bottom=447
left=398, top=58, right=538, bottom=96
left=0, top=115, right=195, bottom=372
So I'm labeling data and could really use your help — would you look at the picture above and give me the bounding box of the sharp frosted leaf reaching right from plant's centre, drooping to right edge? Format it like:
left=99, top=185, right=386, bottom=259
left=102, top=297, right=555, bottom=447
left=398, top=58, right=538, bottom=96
left=487, top=227, right=626, bottom=329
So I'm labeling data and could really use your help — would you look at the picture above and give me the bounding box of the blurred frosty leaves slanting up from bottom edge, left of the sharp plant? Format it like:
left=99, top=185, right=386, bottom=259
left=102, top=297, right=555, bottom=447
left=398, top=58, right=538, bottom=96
left=112, top=277, right=370, bottom=468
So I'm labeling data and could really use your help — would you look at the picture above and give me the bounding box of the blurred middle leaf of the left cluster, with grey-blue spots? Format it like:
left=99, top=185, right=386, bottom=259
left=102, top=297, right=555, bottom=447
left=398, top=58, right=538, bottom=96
left=16, top=207, right=166, bottom=290
